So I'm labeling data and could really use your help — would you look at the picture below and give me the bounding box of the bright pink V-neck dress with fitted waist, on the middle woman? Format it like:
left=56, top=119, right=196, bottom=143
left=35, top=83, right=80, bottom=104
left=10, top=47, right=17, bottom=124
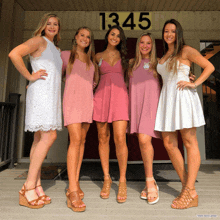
left=93, top=59, right=129, bottom=123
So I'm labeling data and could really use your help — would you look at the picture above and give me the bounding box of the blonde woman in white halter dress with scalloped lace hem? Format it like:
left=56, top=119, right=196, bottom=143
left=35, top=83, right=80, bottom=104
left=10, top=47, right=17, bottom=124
left=9, top=14, right=62, bottom=209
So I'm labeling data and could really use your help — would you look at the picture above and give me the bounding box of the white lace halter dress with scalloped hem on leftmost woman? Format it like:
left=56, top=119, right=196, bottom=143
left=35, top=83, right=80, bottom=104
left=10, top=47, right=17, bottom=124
left=25, top=37, right=62, bottom=132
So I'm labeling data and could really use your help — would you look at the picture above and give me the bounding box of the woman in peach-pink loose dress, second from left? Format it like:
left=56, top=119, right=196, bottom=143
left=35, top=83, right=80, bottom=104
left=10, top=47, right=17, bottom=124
left=61, top=27, right=96, bottom=212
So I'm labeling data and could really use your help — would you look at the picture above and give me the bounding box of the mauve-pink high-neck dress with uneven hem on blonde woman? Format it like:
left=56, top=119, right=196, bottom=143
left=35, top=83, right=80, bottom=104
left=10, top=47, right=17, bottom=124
left=129, top=59, right=161, bottom=138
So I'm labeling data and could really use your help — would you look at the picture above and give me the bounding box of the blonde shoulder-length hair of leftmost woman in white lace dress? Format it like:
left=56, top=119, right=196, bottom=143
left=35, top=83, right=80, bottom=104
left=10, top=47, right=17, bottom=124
left=33, top=13, right=61, bottom=46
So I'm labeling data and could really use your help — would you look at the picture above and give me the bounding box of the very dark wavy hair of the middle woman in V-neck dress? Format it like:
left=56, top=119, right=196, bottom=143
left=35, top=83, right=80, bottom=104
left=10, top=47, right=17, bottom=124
left=104, top=25, right=128, bottom=72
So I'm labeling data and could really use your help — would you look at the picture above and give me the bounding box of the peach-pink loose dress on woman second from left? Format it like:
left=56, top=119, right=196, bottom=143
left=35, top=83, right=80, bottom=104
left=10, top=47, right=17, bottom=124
left=61, top=51, right=94, bottom=126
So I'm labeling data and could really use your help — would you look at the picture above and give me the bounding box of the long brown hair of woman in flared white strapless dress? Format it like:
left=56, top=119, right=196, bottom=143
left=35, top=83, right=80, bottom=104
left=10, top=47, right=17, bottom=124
left=162, top=19, right=186, bottom=73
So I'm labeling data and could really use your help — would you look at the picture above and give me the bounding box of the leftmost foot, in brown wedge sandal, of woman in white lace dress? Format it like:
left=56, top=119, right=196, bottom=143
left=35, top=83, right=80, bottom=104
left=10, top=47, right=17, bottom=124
left=19, top=184, right=45, bottom=209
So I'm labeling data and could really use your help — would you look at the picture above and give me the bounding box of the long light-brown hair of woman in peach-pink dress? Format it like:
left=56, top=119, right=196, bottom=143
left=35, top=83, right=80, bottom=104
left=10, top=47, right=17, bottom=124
left=67, top=27, right=98, bottom=79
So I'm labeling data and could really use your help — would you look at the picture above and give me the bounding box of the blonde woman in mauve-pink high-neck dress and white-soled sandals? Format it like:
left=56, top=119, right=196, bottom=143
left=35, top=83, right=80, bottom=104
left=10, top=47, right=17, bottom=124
left=129, top=33, right=161, bottom=204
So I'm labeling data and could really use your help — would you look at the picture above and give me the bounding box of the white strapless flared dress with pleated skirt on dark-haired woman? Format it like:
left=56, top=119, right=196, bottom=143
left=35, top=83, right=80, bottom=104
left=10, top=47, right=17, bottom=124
left=155, top=61, right=205, bottom=132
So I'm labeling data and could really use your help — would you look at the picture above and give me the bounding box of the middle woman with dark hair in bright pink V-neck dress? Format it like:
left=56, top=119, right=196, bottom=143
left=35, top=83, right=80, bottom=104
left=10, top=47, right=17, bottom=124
left=93, top=26, right=129, bottom=203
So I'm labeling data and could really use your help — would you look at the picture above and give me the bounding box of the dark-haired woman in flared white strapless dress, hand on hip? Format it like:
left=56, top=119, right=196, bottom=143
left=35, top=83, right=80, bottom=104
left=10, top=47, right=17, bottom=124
left=155, top=19, right=214, bottom=209
